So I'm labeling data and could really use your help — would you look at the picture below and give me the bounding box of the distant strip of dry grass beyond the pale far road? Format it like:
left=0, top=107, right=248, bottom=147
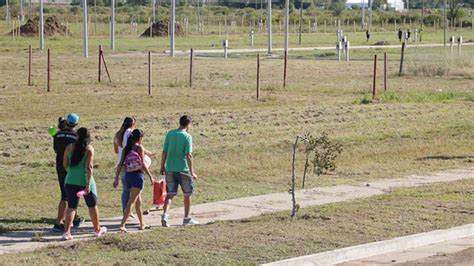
left=0, top=19, right=474, bottom=54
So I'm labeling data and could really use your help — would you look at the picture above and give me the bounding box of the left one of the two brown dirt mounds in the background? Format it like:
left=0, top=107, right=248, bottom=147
left=8, top=16, right=70, bottom=37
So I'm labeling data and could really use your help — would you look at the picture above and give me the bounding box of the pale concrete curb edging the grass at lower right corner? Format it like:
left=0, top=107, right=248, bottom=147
left=264, top=224, right=474, bottom=265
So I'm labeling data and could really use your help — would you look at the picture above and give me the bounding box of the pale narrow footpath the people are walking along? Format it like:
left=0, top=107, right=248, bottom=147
left=0, top=167, right=474, bottom=254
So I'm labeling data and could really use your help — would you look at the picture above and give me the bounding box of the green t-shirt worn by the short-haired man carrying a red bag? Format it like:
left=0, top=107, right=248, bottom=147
left=163, top=128, right=193, bottom=172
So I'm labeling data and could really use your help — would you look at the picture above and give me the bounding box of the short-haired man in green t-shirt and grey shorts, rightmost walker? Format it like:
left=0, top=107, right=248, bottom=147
left=160, top=115, right=198, bottom=227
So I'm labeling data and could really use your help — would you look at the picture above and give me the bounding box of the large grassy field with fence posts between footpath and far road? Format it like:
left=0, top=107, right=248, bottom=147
left=0, top=27, right=474, bottom=235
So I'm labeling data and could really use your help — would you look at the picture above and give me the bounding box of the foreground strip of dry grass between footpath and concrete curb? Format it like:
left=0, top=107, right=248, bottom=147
left=0, top=179, right=474, bottom=265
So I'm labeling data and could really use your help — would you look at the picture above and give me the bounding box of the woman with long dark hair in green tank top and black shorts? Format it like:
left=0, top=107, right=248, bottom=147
left=63, top=127, right=107, bottom=240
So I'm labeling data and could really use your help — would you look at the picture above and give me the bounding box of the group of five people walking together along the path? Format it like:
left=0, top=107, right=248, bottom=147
left=53, top=113, right=197, bottom=240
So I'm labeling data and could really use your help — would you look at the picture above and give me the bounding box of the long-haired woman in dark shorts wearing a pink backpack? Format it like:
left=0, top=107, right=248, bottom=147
left=113, top=129, right=155, bottom=233
